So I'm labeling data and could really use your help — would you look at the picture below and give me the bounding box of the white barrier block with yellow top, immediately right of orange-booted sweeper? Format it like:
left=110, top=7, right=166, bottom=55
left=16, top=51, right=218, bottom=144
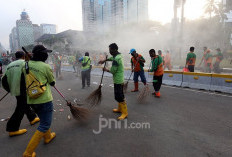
left=163, top=71, right=183, bottom=87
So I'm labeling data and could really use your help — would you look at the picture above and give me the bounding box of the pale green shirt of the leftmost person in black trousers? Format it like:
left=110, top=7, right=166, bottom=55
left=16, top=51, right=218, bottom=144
left=3, top=59, right=25, bottom=96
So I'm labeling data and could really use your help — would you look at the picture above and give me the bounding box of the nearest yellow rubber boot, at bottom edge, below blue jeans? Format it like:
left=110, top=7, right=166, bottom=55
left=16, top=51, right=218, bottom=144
left=23, top=130, right=44, bottom=157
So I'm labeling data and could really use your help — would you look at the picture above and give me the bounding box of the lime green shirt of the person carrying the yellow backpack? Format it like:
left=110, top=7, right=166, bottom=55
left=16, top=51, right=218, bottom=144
left=23, top=61, right=55, bottom=104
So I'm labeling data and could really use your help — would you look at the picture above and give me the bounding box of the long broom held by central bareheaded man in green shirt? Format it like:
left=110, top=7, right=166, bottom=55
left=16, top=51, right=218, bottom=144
left=85, top=55, right=107, bottom=106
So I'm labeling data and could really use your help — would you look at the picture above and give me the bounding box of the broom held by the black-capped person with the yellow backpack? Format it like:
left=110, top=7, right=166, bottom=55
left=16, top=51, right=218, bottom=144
left=54, top=86, right=89, bottom=121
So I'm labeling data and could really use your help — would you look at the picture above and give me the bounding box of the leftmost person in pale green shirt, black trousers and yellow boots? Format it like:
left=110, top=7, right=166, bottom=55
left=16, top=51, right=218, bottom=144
left=2, top=51, right=39, bottom=136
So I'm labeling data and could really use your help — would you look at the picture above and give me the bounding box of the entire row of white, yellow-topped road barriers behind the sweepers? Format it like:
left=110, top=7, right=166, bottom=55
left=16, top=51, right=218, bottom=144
left=59, top=66, right=232, bottom=94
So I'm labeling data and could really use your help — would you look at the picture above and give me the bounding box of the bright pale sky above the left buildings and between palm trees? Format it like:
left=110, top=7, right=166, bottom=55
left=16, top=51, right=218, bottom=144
left=0, top=0, right=217, bottom=49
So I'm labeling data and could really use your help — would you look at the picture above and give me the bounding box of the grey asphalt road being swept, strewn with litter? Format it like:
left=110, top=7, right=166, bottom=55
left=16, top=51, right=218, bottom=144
left=0, top=72, right=232, bottom=157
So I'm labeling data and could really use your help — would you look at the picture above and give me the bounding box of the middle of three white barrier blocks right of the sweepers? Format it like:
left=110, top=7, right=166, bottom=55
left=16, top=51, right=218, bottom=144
left=181, top=72, right=212, bottom=90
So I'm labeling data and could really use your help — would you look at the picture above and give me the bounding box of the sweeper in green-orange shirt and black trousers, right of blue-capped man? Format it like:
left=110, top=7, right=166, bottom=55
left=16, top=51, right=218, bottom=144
left=149, top=49, right=164, bottom=98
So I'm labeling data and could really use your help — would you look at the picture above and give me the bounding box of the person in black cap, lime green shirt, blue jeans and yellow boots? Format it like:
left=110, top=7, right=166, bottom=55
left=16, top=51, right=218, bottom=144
left=23, top=45, right=56, bottom=157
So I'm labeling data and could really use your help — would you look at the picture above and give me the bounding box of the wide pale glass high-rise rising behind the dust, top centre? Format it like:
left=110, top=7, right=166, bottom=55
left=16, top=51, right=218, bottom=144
left=82, top=0, right=148, bottom=31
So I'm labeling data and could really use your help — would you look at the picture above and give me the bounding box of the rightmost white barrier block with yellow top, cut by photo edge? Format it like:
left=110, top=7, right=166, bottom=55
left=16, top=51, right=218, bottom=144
left=210, top=74, right=232, bottom=93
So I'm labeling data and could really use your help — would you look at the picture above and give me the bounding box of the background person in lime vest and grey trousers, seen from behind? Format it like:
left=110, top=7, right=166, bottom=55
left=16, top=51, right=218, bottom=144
left=79, top=52, right=91, bottom=89
